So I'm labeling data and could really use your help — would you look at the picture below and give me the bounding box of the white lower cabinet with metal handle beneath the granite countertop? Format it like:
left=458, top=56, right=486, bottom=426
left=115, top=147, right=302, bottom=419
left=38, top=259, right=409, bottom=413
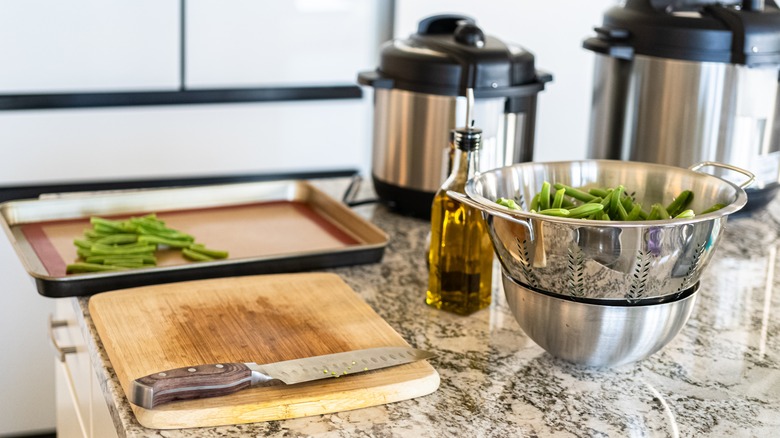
left=50, top=299, right=117, bottom=438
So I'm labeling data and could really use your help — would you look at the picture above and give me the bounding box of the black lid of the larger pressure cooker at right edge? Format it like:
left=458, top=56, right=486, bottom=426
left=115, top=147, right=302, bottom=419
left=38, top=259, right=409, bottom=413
left=583, top=0, right=780, bottom=66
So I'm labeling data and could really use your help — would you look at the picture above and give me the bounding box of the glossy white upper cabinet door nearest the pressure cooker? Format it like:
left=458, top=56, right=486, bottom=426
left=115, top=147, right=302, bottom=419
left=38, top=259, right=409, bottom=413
left=185, top=0, right=389, bottom=88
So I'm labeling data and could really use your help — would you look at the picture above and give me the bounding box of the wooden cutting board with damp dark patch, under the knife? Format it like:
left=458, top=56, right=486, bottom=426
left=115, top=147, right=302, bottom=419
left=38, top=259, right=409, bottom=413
left=89, top=273, right=439, bottom=429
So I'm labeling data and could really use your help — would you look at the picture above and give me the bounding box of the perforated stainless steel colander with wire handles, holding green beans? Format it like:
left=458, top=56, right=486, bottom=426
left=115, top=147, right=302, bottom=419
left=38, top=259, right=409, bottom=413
left=459, top=160, right=752, bottom=302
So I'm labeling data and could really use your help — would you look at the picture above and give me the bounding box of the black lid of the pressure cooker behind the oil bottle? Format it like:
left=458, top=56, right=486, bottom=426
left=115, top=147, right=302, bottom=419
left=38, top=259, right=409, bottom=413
left=358, top=15, right=552, bottom=97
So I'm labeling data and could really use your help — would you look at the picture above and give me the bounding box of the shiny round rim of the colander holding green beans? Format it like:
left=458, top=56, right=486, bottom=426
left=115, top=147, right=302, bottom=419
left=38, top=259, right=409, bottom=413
left=465, top=159, right=747, bottom=228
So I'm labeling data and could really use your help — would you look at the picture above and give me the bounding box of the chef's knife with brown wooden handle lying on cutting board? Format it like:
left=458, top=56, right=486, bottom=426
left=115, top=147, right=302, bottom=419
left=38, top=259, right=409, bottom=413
left=130, top=347, right=435, bottom=409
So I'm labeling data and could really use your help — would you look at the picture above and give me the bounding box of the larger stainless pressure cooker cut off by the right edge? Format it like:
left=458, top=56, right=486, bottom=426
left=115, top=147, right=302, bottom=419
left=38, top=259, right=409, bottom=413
left=583, top=0, right=780, bottom=210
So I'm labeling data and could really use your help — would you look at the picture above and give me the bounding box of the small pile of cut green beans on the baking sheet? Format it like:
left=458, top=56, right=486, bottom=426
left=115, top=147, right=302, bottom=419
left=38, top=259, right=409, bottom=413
left=66, top=214, right=228, bottom=274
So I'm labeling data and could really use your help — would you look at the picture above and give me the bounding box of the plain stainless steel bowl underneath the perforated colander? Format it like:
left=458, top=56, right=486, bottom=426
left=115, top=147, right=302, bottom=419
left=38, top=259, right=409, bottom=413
left=503, top=273, right=698, bottom=367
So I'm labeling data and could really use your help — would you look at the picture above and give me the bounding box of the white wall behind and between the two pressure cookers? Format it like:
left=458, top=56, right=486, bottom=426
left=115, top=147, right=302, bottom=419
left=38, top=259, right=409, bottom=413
left=395, top=0, right=617, bottom=161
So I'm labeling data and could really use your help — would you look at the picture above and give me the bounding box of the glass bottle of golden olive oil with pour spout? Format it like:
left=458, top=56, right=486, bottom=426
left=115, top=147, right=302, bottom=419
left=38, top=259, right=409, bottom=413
left=425, top=128, right=493, bottom=315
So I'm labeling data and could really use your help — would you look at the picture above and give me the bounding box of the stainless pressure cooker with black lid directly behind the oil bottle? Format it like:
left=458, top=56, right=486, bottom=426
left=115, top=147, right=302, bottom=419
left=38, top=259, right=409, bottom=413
left=358, top=15, right=552, bottom=218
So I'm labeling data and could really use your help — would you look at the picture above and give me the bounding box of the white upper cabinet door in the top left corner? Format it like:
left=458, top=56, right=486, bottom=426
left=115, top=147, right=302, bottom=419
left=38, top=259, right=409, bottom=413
left=0, top=0, right=180, bottom=94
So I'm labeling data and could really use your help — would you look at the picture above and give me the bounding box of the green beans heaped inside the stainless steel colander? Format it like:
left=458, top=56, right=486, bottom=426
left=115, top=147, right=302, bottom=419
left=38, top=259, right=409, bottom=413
left=496, top=181, right=725, bottom=221
